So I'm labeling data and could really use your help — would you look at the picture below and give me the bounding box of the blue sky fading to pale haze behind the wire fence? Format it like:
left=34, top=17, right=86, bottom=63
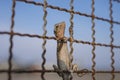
left=0, top=0, right=120, bottom=70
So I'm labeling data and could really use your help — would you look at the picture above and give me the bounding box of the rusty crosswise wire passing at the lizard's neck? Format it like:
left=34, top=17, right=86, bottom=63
left=0, top=31, right=120, bottom=49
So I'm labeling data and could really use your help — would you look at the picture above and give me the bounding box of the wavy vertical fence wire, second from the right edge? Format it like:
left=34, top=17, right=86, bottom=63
left=91, top=0, right=96, bottom=80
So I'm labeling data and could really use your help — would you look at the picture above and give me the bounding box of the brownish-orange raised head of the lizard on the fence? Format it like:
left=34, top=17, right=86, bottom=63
left=54, top=22, right=65, bottom=40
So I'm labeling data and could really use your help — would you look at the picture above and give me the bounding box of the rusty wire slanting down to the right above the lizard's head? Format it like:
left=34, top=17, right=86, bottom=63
left=16, top=0, right=120, bottom=24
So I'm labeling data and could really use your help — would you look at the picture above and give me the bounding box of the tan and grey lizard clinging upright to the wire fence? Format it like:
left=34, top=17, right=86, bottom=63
left=53, top=22, right=78, bottom=80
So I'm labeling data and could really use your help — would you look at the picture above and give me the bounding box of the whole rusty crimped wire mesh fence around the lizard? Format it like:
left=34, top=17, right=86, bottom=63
left=0, top=0, right=120, bottom=80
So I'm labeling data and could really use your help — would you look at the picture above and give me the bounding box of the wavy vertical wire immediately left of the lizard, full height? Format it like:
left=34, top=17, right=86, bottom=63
left=41, top=0, right=47, bottom=80
